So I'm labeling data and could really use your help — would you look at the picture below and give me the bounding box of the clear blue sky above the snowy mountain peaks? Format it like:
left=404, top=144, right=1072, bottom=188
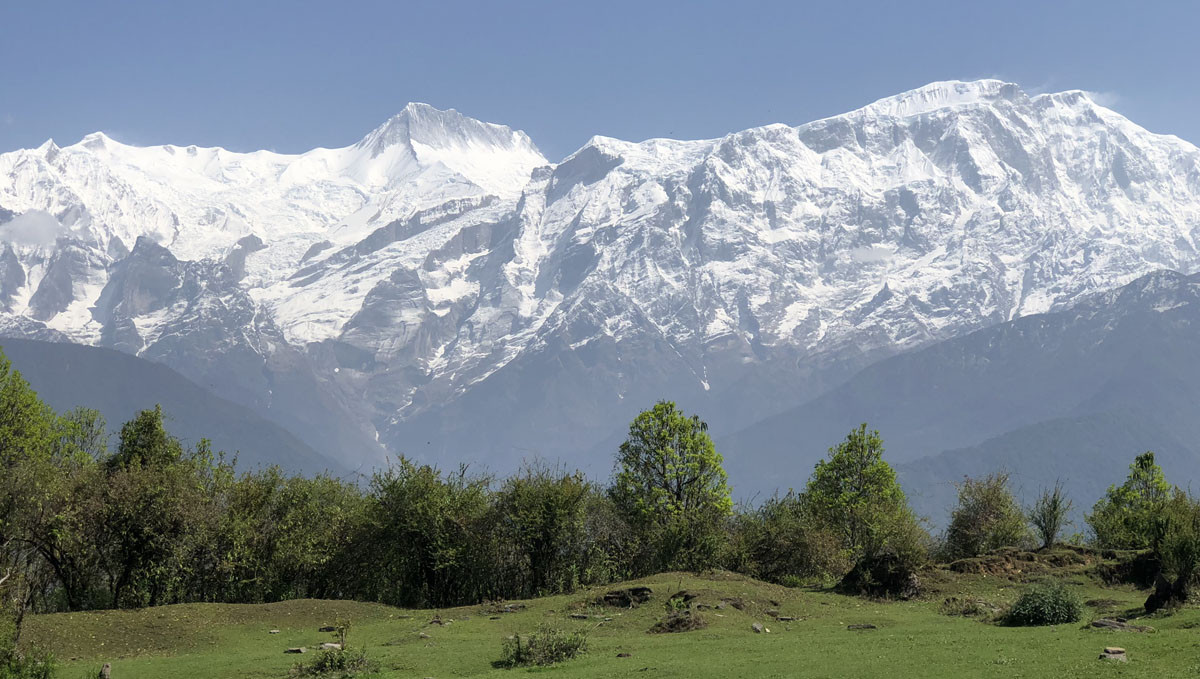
left=0, top=0, right=1200, bottom=160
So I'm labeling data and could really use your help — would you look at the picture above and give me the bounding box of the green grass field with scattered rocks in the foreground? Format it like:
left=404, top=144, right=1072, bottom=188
left=25, top=554, right=1200, bottom=679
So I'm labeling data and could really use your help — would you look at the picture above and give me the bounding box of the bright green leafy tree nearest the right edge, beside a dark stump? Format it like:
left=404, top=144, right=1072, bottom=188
left=1087, top=452, right=1171, bottom=549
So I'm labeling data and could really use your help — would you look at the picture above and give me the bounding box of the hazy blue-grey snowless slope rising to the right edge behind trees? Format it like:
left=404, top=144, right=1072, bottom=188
left=721, top=271, right=1200, bottom=519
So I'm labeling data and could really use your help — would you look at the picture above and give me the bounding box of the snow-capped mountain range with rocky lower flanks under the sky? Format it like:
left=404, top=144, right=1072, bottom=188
left=0, top=80, right=1200, bottom=479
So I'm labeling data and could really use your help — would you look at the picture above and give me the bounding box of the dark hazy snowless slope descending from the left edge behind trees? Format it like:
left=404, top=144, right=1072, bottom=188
left=0, top=338, right=348, bottom=474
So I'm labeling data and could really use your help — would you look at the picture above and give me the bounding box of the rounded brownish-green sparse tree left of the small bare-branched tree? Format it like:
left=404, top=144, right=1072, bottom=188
left=946, top=474, right=1028, bottom=559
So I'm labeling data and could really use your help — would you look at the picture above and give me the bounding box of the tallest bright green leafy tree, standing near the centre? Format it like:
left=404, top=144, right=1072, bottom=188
left=611, top=401, right=733, bottom=578
